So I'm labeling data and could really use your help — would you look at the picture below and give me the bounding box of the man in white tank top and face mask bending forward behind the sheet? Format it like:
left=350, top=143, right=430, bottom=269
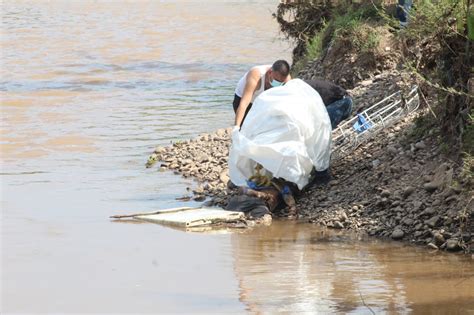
left=233, top=60, right=291, bottom=127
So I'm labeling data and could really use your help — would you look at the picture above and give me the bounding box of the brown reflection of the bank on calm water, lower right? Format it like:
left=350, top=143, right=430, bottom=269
left=232, top=221, right=474, bottom=314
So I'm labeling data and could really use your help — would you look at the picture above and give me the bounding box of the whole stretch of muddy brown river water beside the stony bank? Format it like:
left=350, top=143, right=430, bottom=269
left=0, top=0, right=474, bottom=314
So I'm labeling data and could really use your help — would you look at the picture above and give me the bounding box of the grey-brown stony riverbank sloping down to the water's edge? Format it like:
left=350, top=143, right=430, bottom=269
left=148, top=71, right=474, bottom=252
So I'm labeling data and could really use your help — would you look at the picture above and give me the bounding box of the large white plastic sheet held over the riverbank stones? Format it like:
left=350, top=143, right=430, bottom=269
left=229, top=79, right=332, bottom=189
